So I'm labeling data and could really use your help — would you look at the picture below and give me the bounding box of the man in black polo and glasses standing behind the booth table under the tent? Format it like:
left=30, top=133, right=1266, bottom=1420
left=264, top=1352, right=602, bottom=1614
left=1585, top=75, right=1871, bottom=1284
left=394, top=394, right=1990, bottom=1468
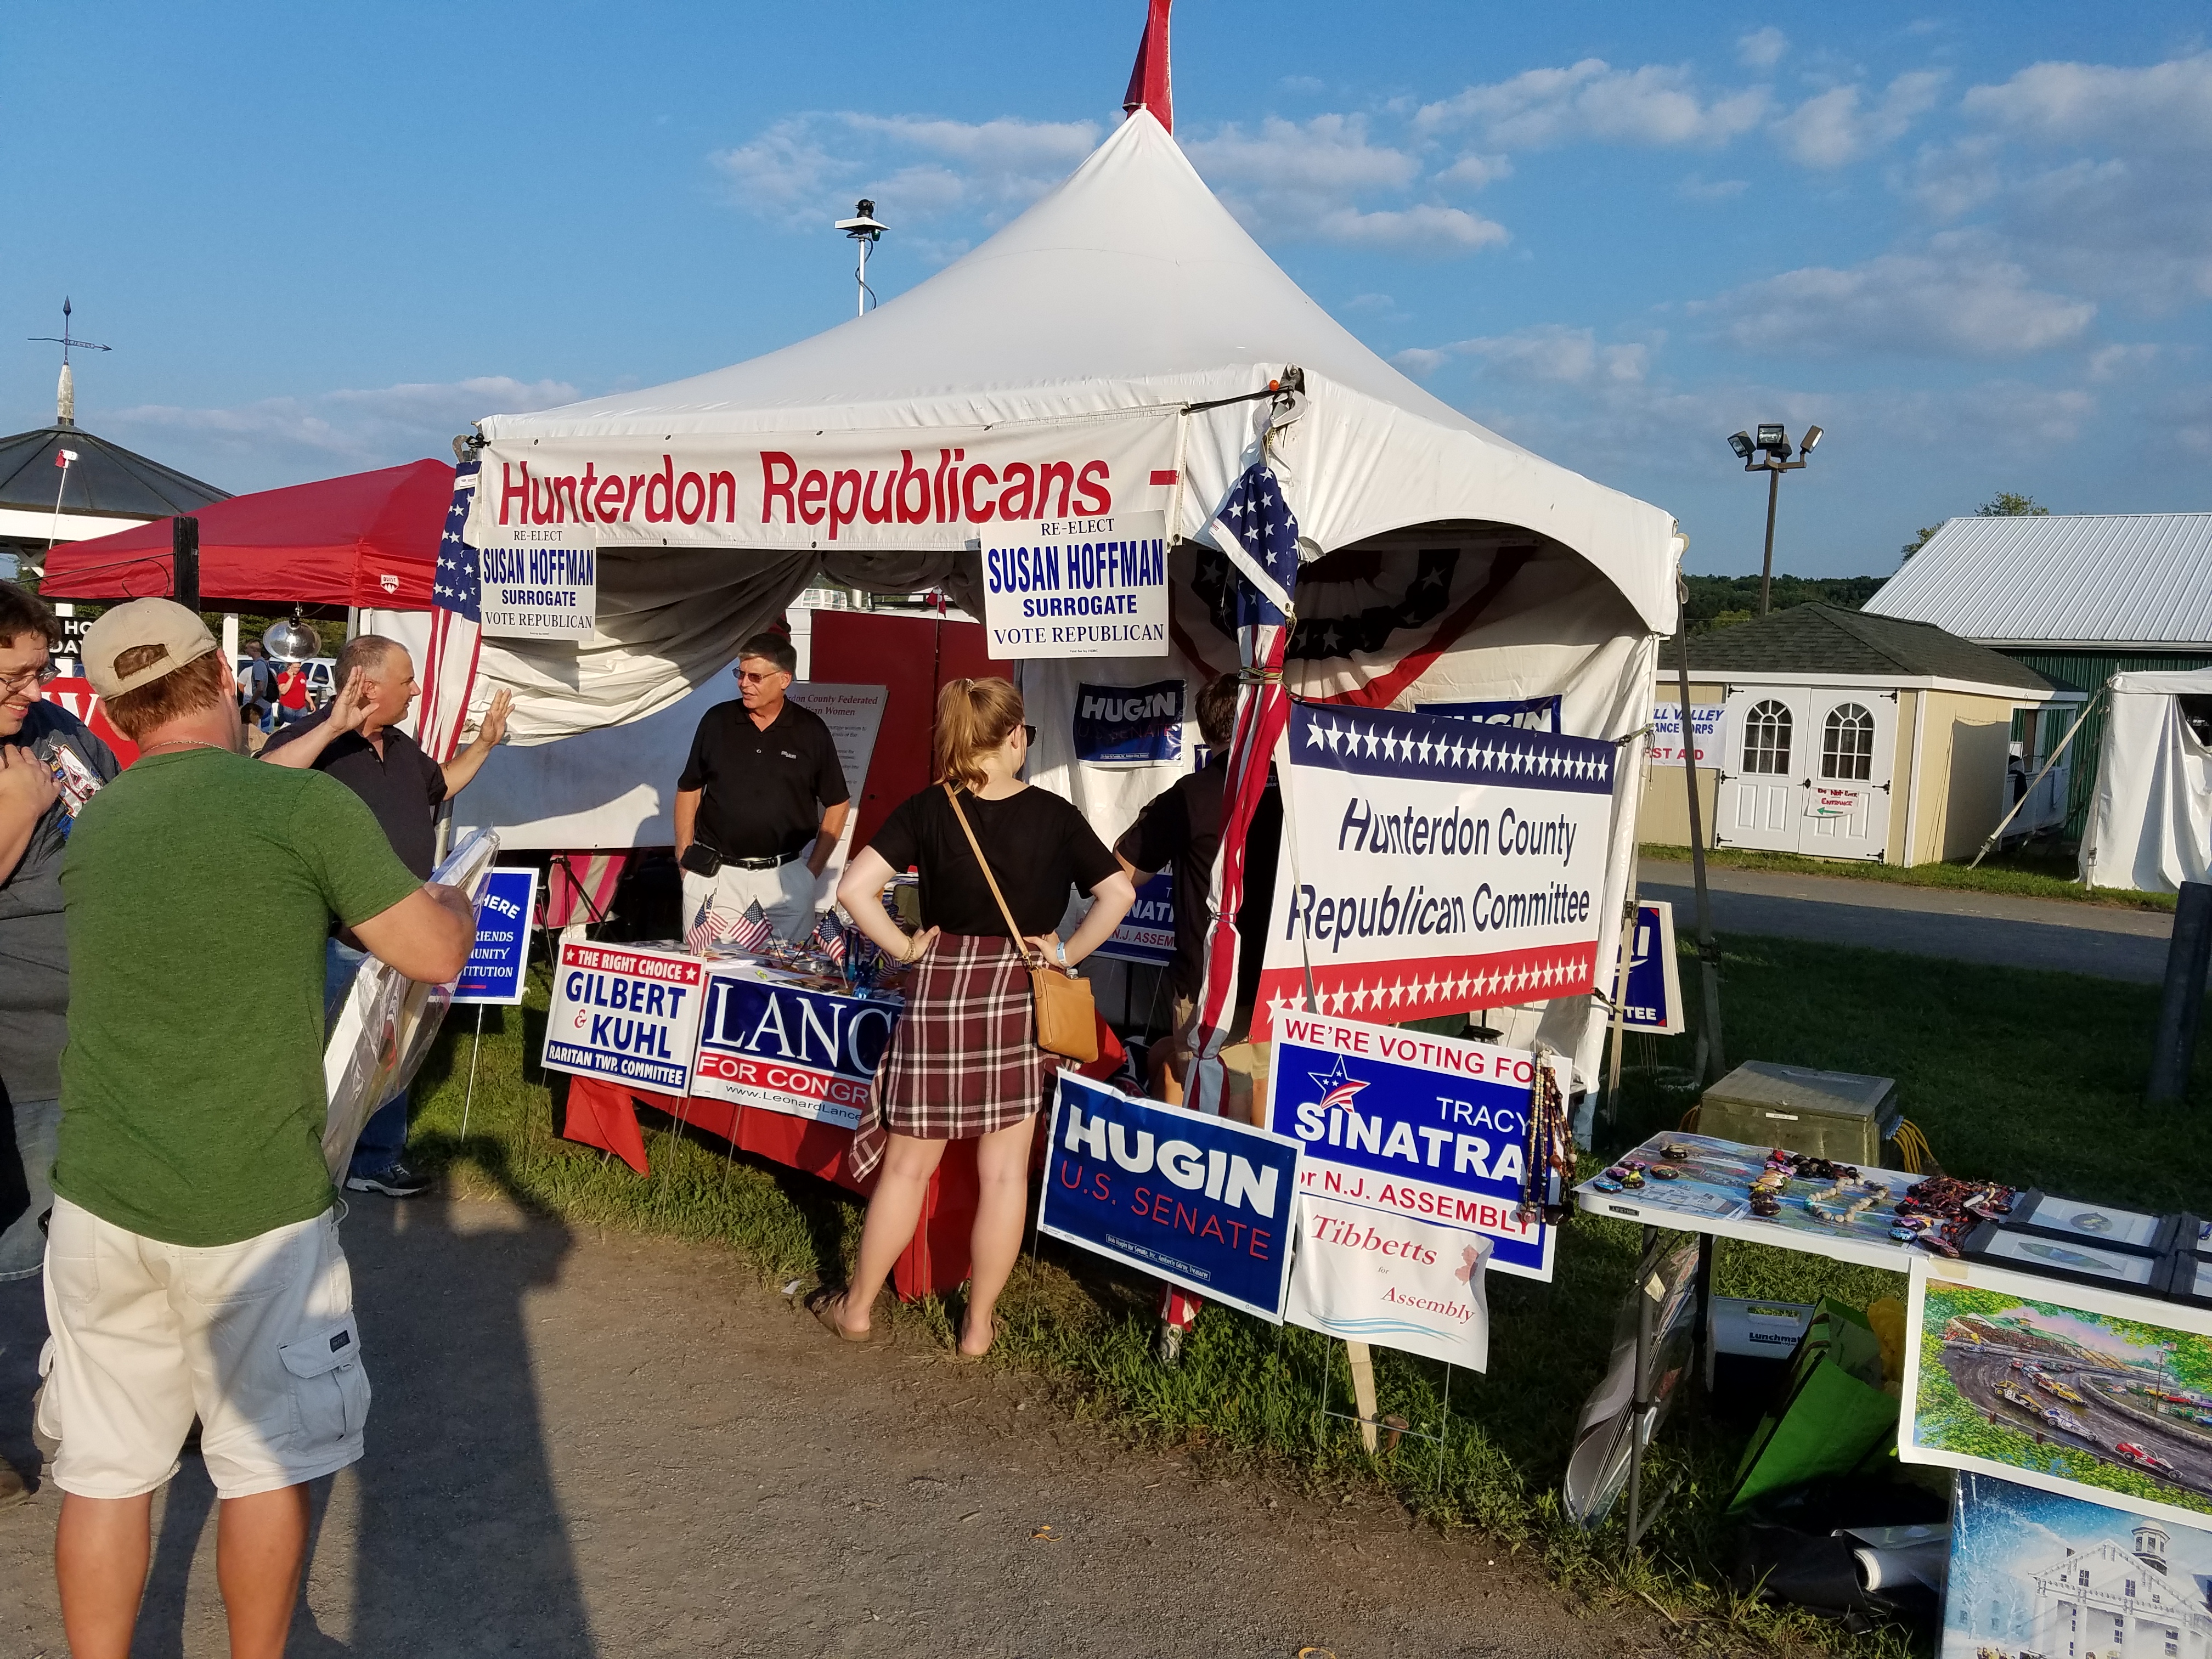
left=675, top=633, right=851, bottom=938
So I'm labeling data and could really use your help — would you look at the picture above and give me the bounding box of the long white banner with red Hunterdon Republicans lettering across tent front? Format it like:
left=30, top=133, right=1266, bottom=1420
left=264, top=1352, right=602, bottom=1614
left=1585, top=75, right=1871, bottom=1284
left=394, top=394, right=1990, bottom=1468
left=467, top=405, right=1181, bottom=555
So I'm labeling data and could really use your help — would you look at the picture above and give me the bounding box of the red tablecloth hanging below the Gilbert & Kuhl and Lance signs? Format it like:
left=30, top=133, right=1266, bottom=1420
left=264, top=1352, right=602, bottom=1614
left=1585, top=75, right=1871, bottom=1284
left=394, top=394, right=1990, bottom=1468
left=562, top=1077, right=975, bottom=1301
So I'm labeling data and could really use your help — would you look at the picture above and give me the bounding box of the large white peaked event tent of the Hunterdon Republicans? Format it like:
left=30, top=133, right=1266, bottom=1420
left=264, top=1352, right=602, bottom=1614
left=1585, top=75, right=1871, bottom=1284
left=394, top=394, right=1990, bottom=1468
left=398, top=109, right=1681, bottom=1092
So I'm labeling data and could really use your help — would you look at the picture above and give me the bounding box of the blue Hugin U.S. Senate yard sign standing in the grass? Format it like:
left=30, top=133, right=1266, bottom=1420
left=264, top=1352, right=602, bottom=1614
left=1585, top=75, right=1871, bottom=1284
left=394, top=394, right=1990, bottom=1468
left=1037, top=1070, right=1299, bottom=1325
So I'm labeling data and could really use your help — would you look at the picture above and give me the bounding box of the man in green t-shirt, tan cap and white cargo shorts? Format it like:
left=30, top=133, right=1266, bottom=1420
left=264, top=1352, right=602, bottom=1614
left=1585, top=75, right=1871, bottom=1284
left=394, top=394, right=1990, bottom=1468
left=38, top=600, right=476, bottom=1659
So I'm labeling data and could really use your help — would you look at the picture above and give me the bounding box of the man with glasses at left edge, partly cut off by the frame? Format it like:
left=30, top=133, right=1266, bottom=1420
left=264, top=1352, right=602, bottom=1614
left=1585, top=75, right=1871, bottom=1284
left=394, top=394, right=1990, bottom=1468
left=0, top=582, right=117, bottom=1506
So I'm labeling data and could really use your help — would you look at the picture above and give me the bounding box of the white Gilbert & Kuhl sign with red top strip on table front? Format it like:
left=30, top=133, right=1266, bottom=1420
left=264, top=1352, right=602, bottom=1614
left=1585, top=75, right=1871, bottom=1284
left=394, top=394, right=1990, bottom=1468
left=542, top=940, right=706, bottom=1095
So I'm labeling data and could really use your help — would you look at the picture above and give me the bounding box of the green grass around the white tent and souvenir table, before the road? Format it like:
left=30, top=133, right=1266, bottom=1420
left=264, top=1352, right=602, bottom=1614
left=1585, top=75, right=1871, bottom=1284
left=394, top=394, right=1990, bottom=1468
left=398, top=938, right=2212, bottom=1659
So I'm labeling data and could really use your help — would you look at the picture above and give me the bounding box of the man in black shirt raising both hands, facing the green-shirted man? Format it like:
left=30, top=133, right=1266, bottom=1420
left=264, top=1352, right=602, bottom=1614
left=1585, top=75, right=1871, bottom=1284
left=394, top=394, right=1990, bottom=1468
left=261, top=633, right=513, bottom=1199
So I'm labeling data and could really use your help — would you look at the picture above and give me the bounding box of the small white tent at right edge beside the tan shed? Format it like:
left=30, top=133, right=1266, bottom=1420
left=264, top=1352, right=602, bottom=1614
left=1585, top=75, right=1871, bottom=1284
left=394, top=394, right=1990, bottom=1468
left=2081, top=668, right=2212, bottom=894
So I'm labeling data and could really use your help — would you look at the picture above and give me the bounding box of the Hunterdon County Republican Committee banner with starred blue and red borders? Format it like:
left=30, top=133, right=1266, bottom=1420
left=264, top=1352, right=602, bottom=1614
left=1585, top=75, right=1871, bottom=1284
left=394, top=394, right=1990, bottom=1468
left=1252, top=703, right=1619, bottom=1040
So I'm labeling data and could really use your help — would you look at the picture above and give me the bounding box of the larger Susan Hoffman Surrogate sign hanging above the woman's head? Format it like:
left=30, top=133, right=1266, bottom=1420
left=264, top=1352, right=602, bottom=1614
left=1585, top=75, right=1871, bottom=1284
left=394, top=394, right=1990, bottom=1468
left=982, top=513, right=1168, bottom=662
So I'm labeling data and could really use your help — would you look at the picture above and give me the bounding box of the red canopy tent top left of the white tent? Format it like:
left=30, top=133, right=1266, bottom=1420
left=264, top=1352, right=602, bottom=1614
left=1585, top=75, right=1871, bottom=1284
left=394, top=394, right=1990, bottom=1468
left=40, top=460, right=454, bottom=611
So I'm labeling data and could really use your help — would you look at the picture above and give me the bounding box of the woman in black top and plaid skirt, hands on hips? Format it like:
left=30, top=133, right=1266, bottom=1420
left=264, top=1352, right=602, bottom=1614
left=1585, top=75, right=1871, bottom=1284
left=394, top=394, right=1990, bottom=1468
left=812, top=679, right=1137, bottom=1358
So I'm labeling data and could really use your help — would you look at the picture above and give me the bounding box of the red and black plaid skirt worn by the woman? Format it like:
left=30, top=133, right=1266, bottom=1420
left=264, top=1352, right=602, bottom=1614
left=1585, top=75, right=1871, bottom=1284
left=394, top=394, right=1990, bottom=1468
left=849, top=934, right=1062, bottom=1179
